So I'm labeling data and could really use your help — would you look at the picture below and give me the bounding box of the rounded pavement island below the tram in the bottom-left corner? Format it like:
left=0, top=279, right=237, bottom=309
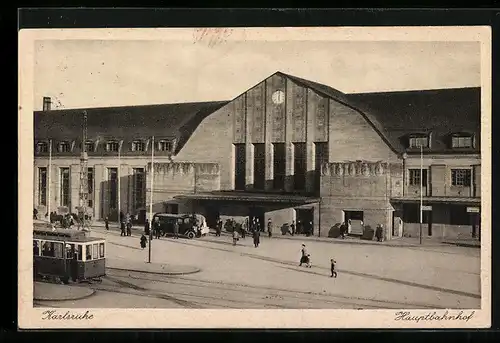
left=33, top=282, right=95, bottom=301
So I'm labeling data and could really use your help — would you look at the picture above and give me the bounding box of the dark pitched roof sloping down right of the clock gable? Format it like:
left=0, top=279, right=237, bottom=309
left=278, top=72, right=481, bottom=153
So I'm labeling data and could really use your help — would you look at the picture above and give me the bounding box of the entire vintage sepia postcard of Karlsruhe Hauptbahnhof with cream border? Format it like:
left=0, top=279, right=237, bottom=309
left=18, top=27, right=491, bottom=329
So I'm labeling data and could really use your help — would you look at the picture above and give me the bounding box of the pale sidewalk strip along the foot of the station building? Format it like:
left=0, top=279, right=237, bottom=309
left=92, top=221, right=481, bottom=248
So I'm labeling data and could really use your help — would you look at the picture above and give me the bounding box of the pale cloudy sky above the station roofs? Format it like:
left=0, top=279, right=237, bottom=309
left=34, top=39, right=481, bottom=110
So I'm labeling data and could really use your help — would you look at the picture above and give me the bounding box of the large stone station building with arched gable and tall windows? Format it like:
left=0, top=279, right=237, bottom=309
left=33, top=72, right=481, bottom=239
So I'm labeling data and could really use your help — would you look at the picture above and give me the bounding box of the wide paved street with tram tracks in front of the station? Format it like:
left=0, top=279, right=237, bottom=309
left=36, top=229, right=480, bottom=309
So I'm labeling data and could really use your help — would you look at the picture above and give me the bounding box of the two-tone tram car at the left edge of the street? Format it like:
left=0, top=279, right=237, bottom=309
left=33, top=227, right=106, bottom=284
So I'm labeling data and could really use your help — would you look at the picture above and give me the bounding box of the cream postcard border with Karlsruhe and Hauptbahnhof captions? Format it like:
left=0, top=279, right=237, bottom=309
left=18, top=26, right=492, bottom=329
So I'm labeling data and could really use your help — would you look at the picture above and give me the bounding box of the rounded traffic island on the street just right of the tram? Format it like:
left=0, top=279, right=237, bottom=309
left=106, top=258, right=201, bottom=275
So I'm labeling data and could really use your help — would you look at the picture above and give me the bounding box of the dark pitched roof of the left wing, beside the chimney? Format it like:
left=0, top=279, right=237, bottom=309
left=34, top=101, right=228, bottom=155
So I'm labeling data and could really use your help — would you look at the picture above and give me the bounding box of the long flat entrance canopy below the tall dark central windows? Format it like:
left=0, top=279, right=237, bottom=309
left=174, top=191, right=320, bottom=204
